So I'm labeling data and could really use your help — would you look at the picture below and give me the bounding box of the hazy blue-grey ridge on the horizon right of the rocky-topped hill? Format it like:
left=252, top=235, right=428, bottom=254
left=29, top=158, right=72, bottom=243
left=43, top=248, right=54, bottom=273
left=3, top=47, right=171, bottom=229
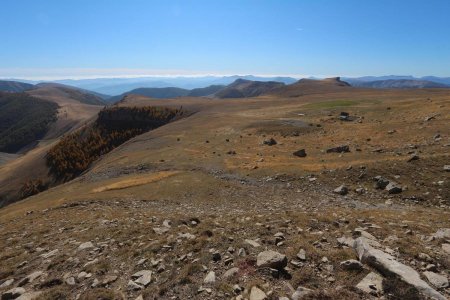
left=350, top=79, right=450, bottom=89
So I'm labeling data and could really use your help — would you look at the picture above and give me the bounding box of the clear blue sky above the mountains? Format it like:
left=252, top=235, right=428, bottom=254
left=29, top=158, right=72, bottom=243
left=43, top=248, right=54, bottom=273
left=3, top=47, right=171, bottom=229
left=0, top=0, right=450, bottom=78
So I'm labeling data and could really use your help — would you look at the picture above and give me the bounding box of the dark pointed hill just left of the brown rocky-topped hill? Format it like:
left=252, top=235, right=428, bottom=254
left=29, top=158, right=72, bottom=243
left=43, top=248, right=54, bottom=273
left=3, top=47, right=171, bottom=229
left=215, top=79, right=284, bottom=98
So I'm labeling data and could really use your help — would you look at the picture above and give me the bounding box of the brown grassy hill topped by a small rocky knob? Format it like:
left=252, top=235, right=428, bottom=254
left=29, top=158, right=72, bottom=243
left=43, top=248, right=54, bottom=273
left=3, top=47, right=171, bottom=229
left=269, top=77, right=351, bottom=97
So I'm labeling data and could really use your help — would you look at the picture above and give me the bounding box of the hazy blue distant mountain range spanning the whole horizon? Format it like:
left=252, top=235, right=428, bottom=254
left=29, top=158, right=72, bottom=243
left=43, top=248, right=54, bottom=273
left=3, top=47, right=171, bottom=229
left=0, top=75, right=450, bottom=104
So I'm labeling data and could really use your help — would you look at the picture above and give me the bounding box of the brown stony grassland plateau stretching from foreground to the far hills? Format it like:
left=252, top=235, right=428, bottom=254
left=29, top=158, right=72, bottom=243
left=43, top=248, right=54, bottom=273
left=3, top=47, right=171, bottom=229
left=0, top=88, right=450, bottom=300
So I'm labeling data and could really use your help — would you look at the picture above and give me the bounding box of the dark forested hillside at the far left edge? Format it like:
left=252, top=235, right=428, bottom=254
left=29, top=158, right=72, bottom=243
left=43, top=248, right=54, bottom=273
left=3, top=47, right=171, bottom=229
left=0, top=92, right=58, bottom=153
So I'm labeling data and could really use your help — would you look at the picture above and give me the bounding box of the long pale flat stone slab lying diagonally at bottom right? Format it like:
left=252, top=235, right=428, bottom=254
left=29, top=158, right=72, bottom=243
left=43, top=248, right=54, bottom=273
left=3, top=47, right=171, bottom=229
left=355, top=238, right=446, bottom=300
